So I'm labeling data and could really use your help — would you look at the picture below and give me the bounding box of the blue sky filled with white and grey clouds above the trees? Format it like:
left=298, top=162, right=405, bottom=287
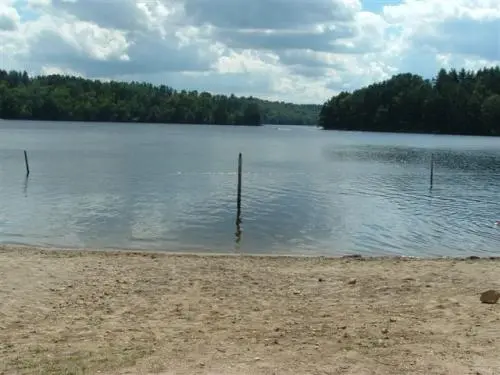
left=0, top=0, right=500, bottom=103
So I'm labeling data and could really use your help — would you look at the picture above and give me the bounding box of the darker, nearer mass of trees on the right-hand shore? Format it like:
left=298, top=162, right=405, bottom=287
left=318, top=67, right=500, bottom=136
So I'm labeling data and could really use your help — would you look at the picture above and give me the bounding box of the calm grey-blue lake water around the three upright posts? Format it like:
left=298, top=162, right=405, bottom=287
left=0, top=121, right=500, bottom=256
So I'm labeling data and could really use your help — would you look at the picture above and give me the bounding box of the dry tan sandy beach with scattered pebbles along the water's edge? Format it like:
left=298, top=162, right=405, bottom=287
left=0, top=247, right=500, bottom=375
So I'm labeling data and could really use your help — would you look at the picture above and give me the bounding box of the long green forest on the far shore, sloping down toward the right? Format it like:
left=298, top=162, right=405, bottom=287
left=0, top=70, right=321, bottom=125
